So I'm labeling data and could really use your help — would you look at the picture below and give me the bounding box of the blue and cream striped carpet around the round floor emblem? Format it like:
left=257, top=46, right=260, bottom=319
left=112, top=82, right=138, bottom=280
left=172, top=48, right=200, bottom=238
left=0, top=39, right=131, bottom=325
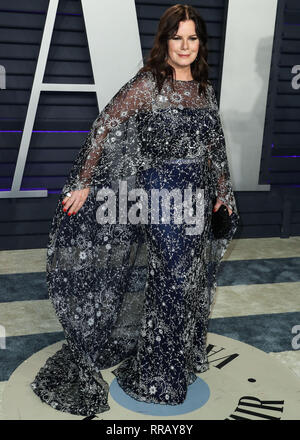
left=0, top=237, right=300, bottom=419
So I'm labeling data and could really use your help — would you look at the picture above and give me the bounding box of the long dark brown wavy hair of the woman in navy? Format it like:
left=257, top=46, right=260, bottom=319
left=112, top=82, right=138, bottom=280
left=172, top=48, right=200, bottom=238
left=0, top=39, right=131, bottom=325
left=140, top=4, right=210, bottom=95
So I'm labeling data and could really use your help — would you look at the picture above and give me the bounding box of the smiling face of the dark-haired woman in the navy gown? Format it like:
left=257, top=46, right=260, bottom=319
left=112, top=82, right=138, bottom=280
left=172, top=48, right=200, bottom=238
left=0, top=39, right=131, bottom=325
left=167, top=20, right=199, bottom=69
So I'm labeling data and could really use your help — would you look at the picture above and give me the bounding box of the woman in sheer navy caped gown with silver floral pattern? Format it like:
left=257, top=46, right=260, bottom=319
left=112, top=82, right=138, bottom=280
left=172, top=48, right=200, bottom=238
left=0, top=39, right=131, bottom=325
left=31, top=5, right=239, bottom=415
